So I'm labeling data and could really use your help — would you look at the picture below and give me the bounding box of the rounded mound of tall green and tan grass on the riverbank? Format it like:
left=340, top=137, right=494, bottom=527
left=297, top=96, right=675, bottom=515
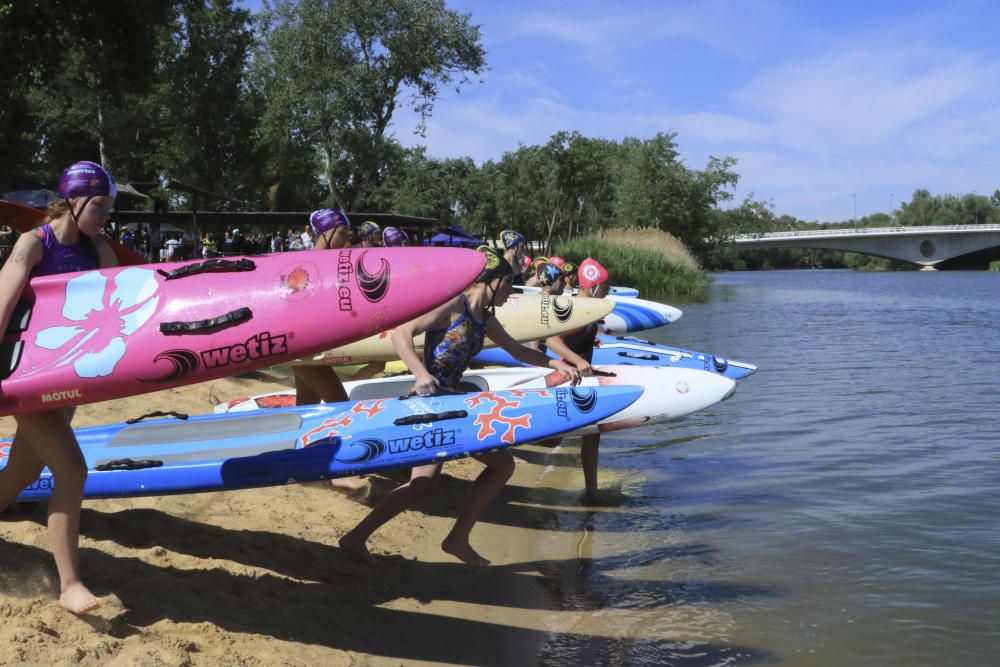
left=556, top=227, right=709, bottom=296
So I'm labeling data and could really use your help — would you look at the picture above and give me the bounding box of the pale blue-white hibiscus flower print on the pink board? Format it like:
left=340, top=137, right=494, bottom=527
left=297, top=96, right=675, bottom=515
left=35, top=268, right=160, bottom=378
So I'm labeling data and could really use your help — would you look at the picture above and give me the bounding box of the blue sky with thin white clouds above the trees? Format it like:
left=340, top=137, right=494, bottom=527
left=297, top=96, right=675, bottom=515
left=247, top=0, right=1000, bottom=221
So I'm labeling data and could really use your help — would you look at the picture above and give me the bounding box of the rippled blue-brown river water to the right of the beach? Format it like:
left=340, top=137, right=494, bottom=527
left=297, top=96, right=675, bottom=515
left=539, top=270, right=1000, bottom=665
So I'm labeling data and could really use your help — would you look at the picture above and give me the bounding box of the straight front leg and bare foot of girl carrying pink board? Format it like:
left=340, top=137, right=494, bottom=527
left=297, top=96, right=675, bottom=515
left=15, top=410, right=98, bottom=614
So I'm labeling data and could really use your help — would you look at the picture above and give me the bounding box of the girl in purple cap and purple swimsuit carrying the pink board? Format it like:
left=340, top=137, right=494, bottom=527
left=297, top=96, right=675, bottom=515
left=0, top=162, right=118, bottom=614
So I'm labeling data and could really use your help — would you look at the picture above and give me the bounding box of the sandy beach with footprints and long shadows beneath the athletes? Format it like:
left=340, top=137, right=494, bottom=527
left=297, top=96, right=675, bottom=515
left=0, top=374, right=600, bottom=665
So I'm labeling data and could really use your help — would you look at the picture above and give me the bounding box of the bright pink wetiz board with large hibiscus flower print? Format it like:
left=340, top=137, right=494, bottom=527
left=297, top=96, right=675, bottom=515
left=0, top=248, right=485, bottom=415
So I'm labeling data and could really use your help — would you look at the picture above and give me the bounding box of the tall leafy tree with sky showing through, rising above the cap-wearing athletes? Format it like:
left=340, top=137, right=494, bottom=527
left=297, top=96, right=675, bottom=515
left=255, top=0, right=485, bottom=210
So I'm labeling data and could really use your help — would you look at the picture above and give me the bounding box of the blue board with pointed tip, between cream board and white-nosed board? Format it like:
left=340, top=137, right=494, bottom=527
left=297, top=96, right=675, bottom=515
left=473, top=334, right=757, bottom=380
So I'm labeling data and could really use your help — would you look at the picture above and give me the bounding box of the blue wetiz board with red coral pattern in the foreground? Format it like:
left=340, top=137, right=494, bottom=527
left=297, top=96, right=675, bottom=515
left=0, top=386, right=642, bottom=501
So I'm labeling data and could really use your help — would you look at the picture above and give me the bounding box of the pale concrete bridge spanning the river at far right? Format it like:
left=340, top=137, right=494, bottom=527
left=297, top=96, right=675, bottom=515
left=733, top=225, right=1000, bottom=270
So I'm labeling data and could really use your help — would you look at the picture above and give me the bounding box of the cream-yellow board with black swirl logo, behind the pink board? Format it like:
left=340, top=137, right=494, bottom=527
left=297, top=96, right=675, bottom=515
left=290, top=294, right=615, bottom=366
